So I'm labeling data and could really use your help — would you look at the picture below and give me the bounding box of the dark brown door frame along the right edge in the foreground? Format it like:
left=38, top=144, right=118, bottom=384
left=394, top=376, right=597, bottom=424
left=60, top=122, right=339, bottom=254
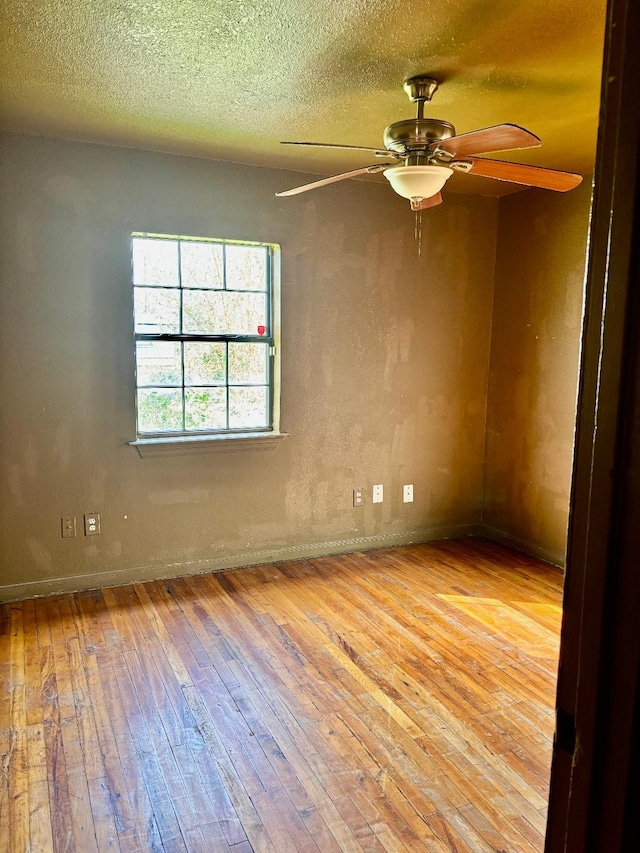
left=545, top=0, right=640, bottom=853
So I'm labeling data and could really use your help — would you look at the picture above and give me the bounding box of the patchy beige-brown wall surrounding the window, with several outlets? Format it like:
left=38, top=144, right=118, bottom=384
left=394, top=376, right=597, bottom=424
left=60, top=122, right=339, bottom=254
left=0, top=136, right=498, bottom=597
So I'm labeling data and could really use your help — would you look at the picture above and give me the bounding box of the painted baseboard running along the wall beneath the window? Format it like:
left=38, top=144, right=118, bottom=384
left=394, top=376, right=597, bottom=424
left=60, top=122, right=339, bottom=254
left=0, top=524, right=482, bottom=601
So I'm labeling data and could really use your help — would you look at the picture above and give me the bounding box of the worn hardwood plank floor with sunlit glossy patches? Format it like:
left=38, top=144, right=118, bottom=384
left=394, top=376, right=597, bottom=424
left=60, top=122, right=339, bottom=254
left=0, top=540, right=562, bottom=853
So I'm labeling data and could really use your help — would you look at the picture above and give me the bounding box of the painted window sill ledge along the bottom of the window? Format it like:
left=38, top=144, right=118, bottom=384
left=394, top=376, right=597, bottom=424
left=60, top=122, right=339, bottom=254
left=129, top=432, right=288, bottom=458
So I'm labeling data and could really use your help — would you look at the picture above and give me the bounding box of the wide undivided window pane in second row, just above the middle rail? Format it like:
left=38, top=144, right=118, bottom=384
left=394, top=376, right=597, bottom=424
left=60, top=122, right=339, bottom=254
left=182, top=290, right=267, bottom=335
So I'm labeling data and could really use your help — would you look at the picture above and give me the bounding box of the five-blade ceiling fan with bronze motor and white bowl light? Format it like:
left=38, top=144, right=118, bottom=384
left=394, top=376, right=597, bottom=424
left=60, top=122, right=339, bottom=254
left=276, top=75, right=582, bottom=210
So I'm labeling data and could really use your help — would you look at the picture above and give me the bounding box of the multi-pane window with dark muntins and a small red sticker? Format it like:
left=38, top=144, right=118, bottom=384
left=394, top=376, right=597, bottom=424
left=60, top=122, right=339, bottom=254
left=132, top=235, right=274, bottom=437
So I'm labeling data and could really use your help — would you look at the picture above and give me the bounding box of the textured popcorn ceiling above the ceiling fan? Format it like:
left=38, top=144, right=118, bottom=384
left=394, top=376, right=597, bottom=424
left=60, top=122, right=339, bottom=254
left=0, top=0, right=605, bottom=195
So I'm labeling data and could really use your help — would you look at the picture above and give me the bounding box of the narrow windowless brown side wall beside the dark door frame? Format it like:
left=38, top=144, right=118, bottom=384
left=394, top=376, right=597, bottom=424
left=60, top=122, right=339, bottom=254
left=483, top=180, right=591, bottom=564
